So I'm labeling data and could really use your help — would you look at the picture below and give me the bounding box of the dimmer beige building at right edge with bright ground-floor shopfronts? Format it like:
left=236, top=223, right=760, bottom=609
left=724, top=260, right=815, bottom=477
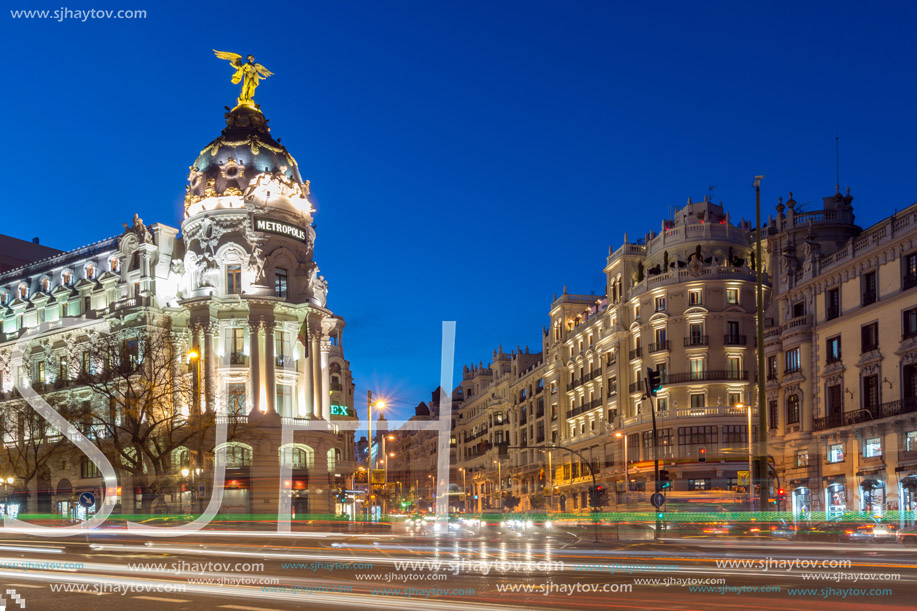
left=765, top=190, right=917, bottom=517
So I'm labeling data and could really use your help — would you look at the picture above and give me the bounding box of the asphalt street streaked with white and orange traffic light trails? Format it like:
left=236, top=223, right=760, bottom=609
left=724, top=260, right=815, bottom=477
left=0, top=525, right=917, bottom=611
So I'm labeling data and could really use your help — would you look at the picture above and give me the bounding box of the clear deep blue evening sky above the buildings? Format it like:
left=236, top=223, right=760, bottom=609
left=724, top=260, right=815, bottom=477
left=7, top=0, right=917, bottom=428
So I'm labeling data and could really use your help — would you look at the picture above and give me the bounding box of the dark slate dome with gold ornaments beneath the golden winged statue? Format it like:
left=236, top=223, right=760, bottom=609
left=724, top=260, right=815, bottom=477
left=185, top=106, right=302, bottom=206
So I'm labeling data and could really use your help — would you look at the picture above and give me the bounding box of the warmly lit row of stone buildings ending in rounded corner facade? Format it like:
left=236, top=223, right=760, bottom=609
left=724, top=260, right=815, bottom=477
left=458, top=200, right=769, bottom=511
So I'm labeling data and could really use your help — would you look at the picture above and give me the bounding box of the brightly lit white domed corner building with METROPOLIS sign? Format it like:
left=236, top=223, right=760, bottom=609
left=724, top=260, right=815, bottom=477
left=0, top=94, right=356, bottom=515
